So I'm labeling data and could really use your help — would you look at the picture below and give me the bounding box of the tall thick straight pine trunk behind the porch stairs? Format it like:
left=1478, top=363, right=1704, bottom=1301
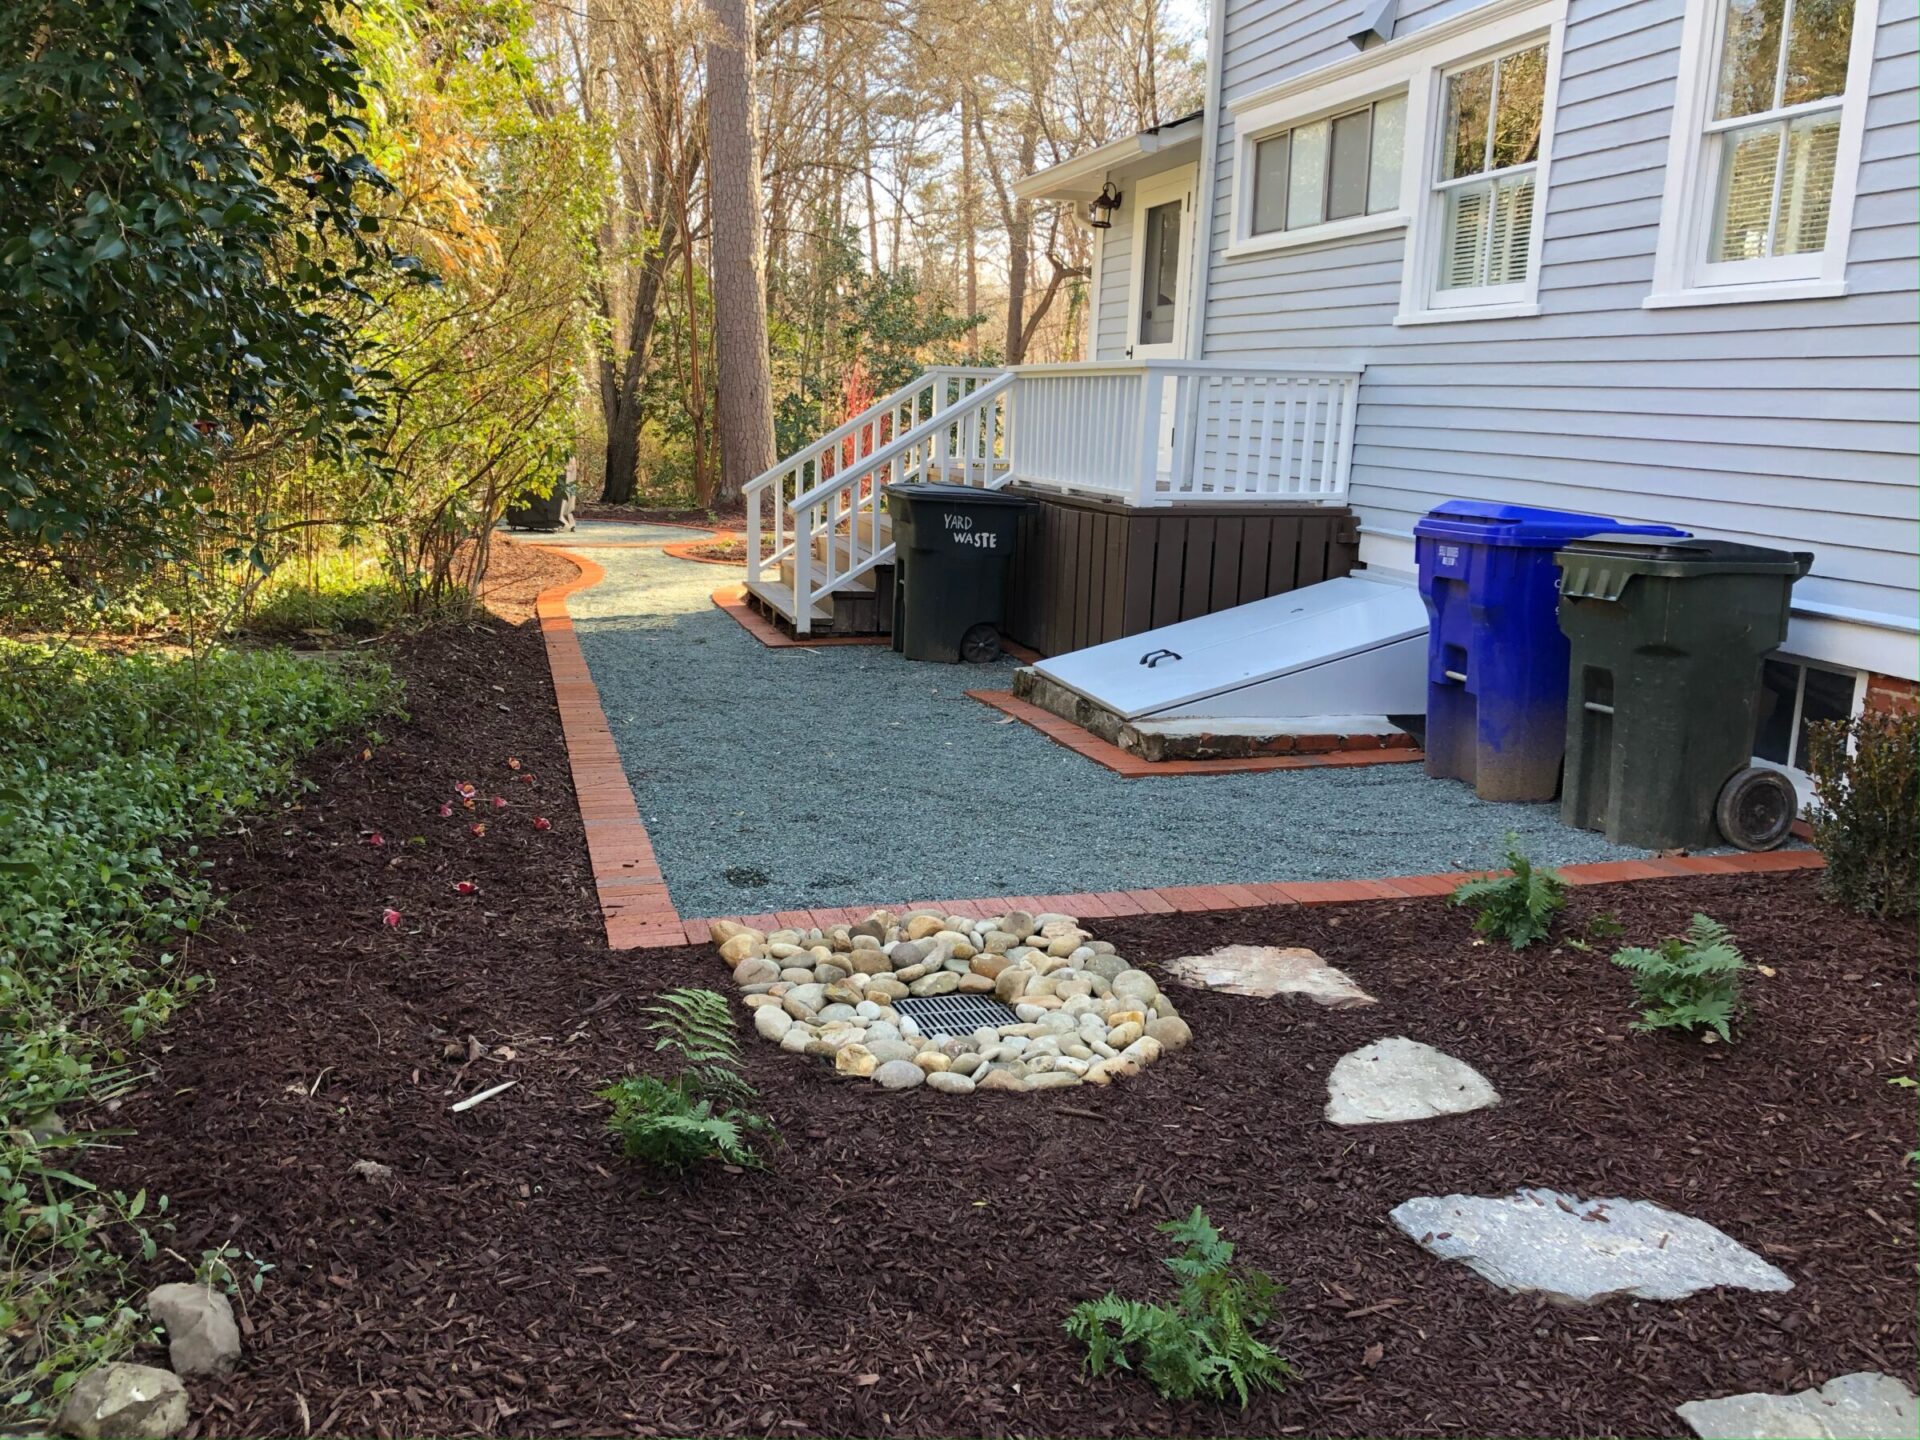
left=707, top=0, right=774, bottom=503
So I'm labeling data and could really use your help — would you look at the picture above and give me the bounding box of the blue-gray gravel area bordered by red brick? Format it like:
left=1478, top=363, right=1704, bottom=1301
left=568, top=549, right=1666, bottom=916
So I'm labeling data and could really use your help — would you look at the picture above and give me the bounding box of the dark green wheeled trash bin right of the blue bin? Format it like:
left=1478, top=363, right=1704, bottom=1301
left=1553, top=538, right=1812, bottom=851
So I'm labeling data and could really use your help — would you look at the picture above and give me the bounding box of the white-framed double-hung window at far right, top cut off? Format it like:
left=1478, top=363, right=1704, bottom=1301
left=1647, top=0, right=1876, bottom=305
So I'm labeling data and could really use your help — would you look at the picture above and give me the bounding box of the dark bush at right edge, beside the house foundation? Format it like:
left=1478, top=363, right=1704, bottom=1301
left=1807, top=710, right=1920, bottom=920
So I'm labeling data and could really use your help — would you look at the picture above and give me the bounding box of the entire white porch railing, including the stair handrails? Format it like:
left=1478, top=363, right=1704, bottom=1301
left=743, top=361, right=1359, bottom=634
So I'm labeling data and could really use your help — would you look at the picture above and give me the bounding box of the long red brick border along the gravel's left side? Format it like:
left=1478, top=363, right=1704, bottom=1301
left=534, top=545, right=687, bottom=950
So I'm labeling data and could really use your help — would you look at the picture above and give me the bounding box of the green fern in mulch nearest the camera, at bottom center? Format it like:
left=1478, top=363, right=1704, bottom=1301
left=1066, top=1206, right=1292, bottom=1409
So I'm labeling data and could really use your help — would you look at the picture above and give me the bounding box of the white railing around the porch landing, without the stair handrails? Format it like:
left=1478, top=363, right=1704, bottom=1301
left=1010, top=361, right=1359, bottom=505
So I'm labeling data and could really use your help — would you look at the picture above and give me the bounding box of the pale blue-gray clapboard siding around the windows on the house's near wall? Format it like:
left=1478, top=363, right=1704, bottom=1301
left=1204, top=0, right=1920, bottom=659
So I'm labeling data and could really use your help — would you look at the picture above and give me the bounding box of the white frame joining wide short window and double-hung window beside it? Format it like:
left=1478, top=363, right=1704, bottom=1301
left=1225, top=0, right=1567, bottom=324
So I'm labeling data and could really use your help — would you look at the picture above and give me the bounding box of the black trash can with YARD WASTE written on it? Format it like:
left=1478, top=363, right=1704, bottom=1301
left=887, top=484, right=1033, bottom=664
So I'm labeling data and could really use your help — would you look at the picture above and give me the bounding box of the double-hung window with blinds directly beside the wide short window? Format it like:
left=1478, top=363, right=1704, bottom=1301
left=1432, top=42, right=1548, bottom=305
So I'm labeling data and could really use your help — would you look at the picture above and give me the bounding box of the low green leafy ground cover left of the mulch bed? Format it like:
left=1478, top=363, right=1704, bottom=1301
left=0, top=641, right=390, bottom=1427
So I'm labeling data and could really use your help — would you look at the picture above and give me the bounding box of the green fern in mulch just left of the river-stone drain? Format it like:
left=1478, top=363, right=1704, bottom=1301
left=599, top=989, right=774, bottom=1173
